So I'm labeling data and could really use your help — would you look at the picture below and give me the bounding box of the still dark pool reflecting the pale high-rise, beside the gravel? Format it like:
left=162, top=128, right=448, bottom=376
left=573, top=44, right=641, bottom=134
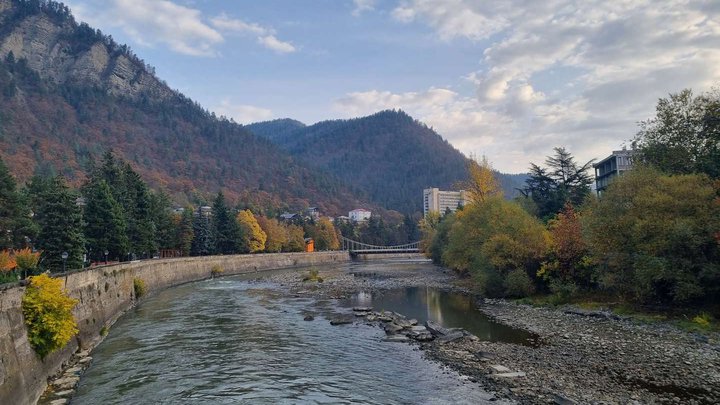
left=349, top=287, right=536, bottom=345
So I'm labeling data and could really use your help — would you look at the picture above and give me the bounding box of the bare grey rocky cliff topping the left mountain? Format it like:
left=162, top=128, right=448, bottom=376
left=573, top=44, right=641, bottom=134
left=0, top=0, right=175, bottom=100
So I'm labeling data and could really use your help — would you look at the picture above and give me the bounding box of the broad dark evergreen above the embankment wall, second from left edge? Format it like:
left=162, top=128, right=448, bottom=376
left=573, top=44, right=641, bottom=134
left=33, top=176, right=85, bottom=271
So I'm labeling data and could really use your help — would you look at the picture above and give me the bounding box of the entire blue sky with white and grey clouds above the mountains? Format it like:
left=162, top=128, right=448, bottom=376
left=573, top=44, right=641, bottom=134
left=65, top=0, right=720, bottom=172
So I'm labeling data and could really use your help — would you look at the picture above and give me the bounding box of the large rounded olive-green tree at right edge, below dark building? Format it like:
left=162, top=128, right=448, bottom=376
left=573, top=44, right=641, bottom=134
left=583, top=167, right=720, bottom=304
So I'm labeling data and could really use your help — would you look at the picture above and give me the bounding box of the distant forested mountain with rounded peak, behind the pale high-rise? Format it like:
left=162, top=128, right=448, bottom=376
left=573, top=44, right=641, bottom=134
left=247, top=110, right=525, bottom=213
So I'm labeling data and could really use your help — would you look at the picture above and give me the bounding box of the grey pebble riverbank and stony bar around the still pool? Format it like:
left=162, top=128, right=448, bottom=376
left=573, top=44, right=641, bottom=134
left=262, top=262, right=720, bottom=404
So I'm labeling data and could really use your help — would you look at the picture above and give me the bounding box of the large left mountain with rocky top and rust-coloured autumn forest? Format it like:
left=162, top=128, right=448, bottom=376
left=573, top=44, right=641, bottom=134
left=0, top=0, right=368, bottom=214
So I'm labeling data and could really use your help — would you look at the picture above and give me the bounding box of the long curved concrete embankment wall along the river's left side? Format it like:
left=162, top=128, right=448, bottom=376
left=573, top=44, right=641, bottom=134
left=0, top=252, right=349, bottom=405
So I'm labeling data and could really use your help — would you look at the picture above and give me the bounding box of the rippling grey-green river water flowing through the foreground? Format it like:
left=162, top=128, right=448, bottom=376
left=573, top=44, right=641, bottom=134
left=72, top=278, right=504, bottom=404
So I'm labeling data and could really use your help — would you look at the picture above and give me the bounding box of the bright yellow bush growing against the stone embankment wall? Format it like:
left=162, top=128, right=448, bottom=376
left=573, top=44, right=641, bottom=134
left=22, top=274, right=78, bottom=359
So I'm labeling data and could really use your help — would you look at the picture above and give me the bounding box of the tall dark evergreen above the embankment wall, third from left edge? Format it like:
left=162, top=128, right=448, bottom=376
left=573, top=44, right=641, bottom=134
left=84, top=180, right=130, bottom=261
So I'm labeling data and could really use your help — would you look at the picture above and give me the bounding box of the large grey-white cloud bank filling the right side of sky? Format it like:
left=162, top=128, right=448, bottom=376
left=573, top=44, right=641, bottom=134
left=388, top=0, right=720, bottom=171
